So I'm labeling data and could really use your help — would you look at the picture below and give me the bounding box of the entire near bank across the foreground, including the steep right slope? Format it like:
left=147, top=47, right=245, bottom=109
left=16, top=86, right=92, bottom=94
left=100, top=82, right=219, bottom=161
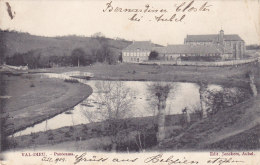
left=9, top=91, right=260, bottom=152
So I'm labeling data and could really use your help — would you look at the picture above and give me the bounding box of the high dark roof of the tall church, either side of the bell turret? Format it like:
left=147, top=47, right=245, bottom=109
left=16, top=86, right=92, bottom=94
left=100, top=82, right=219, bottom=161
left=185, top=34, right=243, bottom=42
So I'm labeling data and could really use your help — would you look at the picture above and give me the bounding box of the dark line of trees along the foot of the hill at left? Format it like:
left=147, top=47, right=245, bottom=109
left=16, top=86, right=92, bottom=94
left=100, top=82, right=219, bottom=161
left=4, top=36, right=122, bottom=69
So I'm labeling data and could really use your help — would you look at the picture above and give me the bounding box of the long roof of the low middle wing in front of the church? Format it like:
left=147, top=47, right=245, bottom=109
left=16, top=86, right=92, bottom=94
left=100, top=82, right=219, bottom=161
left=157, top=45, right=221, bottom=54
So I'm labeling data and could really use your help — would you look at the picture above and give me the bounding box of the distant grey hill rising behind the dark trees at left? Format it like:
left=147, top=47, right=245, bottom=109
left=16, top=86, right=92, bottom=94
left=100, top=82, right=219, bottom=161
left=0, top=30, right=132, bottom=57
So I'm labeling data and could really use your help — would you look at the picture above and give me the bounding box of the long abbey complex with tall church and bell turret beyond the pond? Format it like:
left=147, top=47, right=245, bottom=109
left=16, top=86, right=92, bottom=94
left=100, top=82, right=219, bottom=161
left=122, top=30, right=245, bottom=63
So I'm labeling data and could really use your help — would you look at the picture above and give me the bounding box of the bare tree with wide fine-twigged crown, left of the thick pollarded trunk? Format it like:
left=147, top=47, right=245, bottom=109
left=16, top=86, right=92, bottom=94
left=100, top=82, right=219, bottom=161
left=84, top=81, right=133, bottom=151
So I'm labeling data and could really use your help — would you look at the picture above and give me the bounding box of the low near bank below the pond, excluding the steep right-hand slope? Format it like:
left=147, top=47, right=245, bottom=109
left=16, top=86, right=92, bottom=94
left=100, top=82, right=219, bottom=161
left=11, top=114, right=198, bottom=151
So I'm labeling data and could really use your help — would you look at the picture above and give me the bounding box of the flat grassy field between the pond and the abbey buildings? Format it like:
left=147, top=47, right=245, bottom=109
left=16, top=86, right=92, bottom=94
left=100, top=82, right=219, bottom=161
left=36, top=63, right=258, bottom=90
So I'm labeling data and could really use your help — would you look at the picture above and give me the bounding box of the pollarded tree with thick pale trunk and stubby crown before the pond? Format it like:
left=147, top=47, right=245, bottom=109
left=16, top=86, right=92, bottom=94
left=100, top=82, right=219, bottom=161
left=148, top=83, right=173, bottom=143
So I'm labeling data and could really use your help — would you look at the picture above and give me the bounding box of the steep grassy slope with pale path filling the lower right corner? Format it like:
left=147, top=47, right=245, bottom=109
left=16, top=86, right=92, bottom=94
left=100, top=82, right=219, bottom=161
left=157, top=90, right=260, bottom=151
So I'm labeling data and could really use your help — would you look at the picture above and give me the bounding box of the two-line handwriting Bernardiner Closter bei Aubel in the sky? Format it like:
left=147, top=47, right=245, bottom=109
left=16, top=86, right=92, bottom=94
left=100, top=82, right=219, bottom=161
left=103, top=0, right=212, bottom=22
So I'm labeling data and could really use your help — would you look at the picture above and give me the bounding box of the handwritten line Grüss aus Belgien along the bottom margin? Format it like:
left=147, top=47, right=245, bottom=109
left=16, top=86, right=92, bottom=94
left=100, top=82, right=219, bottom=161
left=38, top=152, right=245, bottom=165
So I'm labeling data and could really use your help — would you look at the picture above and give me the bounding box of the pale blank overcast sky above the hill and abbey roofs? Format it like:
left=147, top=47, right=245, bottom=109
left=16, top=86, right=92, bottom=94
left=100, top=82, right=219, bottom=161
left=0, top=0, right=260, bottom=45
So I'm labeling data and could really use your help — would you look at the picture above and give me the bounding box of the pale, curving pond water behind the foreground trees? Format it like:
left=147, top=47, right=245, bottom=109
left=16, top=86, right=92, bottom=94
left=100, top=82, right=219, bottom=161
left=14, top=73, right=222, bottom=136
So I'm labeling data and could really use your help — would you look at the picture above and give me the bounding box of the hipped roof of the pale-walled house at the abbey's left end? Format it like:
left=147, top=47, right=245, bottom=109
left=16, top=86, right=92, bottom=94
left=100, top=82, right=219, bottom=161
left=123, top=41, right=155, bottom=51
